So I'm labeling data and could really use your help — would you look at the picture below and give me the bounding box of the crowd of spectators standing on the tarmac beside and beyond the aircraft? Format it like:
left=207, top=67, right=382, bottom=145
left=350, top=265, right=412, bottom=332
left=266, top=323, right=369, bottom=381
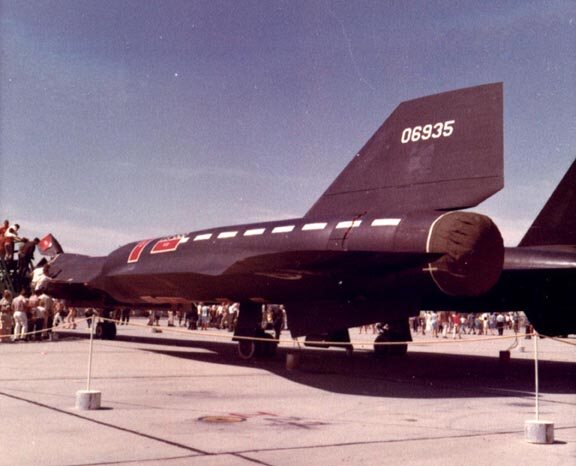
left=0, top=289, right=531, bottom=341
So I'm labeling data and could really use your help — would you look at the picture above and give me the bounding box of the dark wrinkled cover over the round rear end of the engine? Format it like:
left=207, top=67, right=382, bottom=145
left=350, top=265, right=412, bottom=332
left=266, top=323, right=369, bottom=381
left=426, top=212, right=504, bottom=296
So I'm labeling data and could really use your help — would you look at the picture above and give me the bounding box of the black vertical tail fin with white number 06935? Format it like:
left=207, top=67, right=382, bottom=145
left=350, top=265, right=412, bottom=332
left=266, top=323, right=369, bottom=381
left=306, top=83, right=503, bottom=217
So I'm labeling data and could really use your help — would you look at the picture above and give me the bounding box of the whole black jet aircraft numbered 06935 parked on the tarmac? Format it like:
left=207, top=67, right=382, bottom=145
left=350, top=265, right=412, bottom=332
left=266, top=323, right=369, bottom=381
left=41, top=83, right=576, bottom=357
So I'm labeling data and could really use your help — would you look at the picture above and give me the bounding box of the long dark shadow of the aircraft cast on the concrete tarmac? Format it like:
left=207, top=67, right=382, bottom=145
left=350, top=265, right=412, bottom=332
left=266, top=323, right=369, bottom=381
left=59, top=337, right=576, bottom=400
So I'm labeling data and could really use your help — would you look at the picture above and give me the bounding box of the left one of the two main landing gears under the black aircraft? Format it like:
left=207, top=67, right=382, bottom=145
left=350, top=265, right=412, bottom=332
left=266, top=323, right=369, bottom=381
left=233, top=302, right=278, bottom=360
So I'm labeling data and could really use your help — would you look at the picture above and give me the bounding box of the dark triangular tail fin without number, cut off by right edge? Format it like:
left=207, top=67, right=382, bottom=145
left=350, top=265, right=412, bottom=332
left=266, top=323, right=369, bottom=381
left=518, top=161, right=576, bottom=246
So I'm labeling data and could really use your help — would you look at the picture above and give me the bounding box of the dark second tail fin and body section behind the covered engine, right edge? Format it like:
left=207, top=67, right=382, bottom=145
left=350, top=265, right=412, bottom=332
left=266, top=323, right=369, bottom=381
left=435, top=157, right=576, bottom=336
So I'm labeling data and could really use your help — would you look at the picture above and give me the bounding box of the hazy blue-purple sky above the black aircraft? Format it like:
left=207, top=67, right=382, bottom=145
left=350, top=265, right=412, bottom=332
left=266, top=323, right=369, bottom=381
left=0, top=0, right=576, bottom=254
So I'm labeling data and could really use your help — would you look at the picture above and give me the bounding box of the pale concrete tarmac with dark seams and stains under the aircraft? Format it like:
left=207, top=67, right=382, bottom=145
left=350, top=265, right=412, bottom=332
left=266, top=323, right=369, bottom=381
left=0, top=319, right=576, bottom=466
